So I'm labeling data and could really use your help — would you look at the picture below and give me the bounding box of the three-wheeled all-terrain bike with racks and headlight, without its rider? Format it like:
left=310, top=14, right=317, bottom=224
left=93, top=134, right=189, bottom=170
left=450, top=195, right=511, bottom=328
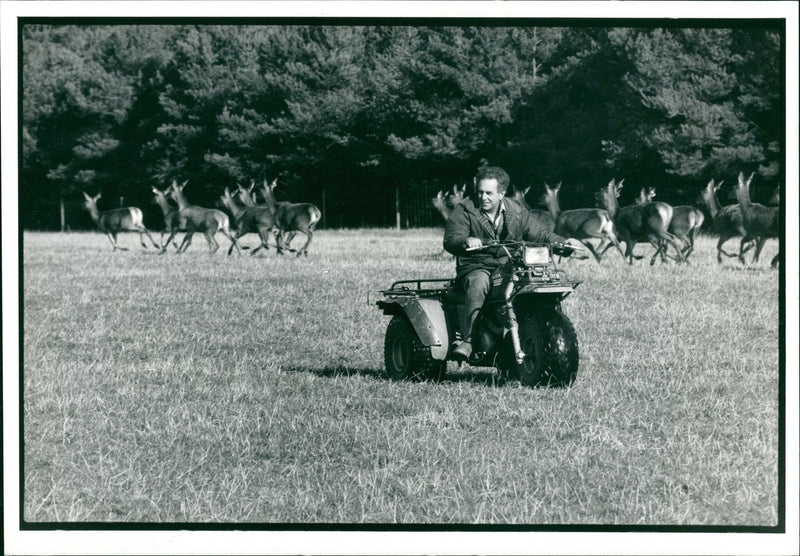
left=375, top=241, right=580, bottom=387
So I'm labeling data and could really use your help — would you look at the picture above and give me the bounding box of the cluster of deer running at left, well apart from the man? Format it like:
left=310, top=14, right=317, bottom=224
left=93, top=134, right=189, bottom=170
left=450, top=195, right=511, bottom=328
left=83, top=180, right=322, bottom=256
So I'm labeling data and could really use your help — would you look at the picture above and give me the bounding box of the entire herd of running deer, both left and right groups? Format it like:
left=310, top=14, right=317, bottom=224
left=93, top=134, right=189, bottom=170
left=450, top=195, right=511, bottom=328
left=83, top=173, right=780, bottom=267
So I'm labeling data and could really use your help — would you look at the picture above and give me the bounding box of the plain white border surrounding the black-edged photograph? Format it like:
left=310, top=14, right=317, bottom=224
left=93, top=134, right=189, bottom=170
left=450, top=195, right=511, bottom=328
left=0, top=0, right=800, bottom=556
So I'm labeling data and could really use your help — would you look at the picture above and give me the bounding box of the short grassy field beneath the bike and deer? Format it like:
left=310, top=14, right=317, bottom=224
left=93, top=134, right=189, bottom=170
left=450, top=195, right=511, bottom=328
left=22, top=229, right=779, bottom=526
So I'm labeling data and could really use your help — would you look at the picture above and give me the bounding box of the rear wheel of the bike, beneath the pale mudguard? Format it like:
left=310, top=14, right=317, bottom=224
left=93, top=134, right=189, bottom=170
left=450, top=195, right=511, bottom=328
left=383, top=315, right=447, bottom=380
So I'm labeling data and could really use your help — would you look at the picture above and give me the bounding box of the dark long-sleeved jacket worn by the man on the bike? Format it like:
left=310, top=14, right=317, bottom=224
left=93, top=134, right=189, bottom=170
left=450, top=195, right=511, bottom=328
left=443, top=197, right=564, bottom=279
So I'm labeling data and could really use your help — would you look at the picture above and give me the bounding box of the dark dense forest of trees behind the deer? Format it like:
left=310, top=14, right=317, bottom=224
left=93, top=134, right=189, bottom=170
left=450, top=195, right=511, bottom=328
left=19, top=20, right=785, bottom=229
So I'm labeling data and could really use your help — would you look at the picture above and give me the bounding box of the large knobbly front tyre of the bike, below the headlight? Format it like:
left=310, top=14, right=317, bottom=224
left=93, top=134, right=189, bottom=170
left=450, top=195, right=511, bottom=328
left=517, top=308, right=579, bottom=388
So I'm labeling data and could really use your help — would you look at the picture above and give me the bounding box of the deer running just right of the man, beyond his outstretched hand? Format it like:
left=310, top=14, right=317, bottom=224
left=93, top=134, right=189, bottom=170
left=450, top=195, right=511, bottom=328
left=544, top=183, right=625, bottom=263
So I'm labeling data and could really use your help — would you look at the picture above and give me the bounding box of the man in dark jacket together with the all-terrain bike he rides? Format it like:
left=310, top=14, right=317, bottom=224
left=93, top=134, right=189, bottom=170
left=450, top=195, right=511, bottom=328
left=377, top=167, right=578, bottom=386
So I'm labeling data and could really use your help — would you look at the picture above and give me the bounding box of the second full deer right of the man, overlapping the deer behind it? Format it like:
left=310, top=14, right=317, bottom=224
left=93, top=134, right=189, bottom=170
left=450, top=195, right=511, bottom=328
left=597, top=179, right=684, bottom=265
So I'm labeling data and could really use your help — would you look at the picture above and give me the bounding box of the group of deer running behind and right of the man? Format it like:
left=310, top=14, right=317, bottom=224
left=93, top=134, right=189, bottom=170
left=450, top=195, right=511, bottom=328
left=433, top=173, right=780, bottom=267
